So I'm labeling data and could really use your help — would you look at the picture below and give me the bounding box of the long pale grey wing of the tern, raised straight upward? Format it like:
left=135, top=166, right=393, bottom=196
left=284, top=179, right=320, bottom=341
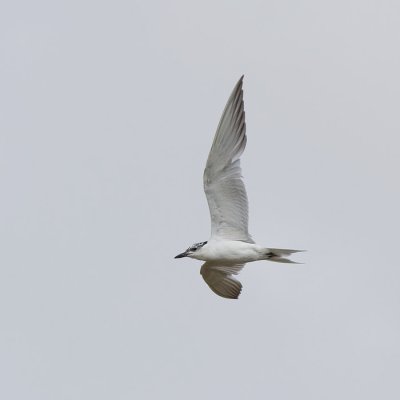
left=203, top=76, right=254, bottom=243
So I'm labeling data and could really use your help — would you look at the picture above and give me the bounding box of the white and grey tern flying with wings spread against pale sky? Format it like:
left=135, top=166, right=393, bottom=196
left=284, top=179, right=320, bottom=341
left=175, top=75, right=303, bottom=299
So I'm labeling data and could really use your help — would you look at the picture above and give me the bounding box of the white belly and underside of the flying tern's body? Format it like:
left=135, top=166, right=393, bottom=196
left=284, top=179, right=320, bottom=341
left=196, top=241, right=260, bottom=264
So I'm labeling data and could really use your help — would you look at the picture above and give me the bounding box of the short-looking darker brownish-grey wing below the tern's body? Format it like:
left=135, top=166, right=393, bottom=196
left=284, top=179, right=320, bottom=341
left=200, top=262, right=244, bottom=299
